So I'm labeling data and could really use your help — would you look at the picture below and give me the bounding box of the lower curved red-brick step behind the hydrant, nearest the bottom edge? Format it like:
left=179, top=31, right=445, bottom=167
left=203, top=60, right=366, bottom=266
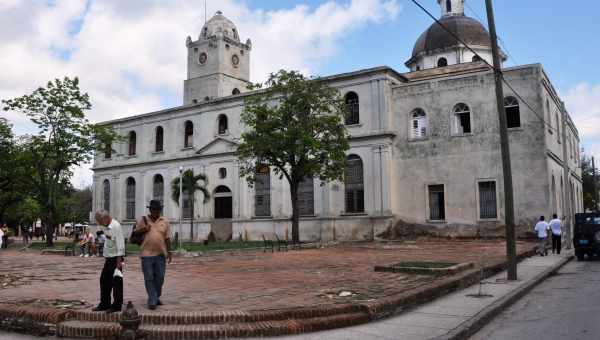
left=56, top=312, right=370, bottom=340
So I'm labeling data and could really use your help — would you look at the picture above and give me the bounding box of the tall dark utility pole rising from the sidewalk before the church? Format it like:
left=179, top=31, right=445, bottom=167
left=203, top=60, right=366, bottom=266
left=485, top=0, right=517, bottom=281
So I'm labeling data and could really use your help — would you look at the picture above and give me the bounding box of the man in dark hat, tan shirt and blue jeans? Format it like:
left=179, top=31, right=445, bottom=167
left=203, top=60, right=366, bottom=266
left=136, top=200, right=171, bottom=309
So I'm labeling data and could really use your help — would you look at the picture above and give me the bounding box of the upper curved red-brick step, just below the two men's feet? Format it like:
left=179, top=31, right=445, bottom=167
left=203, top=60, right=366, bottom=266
left=69, top=304, right=362, bottom=325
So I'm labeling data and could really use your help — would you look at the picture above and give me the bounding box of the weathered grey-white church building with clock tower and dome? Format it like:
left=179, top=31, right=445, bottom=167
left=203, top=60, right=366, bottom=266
left=93, top=0, right=583, bottom=241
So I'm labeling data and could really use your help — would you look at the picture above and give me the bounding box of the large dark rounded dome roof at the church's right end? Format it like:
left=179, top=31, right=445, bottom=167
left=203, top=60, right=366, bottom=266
left=412, top=15, right=492, bottom=58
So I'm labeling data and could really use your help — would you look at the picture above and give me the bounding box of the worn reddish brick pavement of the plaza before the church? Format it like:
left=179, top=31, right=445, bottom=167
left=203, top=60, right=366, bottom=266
left=0, top=240, right=532, bottom=314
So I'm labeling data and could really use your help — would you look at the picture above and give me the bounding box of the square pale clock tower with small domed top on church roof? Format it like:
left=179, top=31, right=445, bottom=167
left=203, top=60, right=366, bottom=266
left=183, top=11, right=252, bottom=105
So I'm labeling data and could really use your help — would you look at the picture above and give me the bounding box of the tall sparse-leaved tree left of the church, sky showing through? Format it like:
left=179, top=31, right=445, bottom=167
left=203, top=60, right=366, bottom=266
left=2, top=77, right=117, bottom=246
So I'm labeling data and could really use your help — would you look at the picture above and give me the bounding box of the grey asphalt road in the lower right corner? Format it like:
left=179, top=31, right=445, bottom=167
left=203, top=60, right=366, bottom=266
left=470, top=259, right=600, bottom=340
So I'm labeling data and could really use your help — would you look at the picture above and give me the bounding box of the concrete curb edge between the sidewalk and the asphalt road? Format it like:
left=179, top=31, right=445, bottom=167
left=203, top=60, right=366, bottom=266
left=433, top=255, right=574, bottom=340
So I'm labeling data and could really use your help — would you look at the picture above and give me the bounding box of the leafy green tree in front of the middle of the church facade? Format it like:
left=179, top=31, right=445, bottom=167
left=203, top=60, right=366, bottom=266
left=237, top=70, right=349, bottom=243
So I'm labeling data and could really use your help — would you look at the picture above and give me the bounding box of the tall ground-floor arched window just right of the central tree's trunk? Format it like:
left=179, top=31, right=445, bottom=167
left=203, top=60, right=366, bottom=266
left=345, top=155, right=365, bottom=213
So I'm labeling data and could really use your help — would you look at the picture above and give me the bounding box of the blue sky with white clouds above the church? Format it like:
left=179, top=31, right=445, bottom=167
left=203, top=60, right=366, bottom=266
left=0, top=0, right=600, bottom=187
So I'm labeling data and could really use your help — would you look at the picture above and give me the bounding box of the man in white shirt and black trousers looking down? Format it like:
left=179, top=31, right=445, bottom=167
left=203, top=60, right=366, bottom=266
left=92, top=210, right=125, bottom=313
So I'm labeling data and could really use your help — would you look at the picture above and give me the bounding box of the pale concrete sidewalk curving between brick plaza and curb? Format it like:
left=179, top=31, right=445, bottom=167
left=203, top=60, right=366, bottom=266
left=253, top=252, right=573, bottom=340
